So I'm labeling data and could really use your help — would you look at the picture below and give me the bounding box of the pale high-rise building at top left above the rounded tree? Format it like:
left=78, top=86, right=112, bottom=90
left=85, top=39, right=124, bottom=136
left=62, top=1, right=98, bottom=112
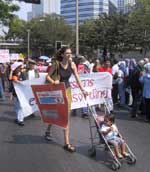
left=28, top=0, right=60, bottom=18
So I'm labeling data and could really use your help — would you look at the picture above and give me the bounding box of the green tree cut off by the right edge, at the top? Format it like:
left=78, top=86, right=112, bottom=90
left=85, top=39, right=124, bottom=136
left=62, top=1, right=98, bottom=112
left=129, top=0, right=150, bottom=54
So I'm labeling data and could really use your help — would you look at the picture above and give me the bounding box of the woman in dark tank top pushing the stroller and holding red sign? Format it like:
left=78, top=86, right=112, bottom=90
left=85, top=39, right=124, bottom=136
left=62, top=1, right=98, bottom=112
left=45, top=47, right=87, bottom=152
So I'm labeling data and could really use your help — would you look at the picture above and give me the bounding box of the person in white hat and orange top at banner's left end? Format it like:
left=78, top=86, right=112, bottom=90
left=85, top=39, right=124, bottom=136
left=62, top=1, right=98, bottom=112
left=9, top=62, right=24, bottom=126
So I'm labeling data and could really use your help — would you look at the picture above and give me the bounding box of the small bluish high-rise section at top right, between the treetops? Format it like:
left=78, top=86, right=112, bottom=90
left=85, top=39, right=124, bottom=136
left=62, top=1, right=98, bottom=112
left=118, top=0, right=135, bottom=14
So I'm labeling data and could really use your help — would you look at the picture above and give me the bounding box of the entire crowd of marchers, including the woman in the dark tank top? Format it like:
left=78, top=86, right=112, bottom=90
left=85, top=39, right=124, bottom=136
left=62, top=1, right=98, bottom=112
left=0, top=47, right=150, bottom=152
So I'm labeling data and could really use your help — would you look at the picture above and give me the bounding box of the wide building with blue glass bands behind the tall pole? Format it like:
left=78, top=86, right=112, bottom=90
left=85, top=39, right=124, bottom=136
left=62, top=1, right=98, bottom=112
left=60, top=0, right=118, bottom=25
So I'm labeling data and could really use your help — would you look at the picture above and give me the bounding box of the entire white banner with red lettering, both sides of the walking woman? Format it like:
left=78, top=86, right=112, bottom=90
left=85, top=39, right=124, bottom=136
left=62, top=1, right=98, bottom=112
left=14, top=72, right=112, bottom=117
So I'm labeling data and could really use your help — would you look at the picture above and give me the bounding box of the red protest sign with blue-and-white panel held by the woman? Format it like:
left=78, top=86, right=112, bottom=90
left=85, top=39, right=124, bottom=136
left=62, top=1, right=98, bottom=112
left=31, top=83, right=68, bottom=128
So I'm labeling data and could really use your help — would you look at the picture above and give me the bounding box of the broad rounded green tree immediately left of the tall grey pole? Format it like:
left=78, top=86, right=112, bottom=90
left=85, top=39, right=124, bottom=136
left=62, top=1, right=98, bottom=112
left=24, top=14, right=73, bottom=53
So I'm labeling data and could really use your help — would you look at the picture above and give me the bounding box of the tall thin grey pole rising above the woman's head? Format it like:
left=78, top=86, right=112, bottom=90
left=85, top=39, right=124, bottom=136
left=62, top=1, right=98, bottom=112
left=76, top=0, right=79, bottom=55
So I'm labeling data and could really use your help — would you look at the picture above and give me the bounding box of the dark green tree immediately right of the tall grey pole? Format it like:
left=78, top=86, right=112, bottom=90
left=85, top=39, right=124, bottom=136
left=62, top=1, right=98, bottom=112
left=80, top=14, right=128, bottom=56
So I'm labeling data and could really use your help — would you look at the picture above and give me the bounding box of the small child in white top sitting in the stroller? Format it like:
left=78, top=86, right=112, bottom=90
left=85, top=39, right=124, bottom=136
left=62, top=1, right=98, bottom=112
left=100, top=114, right=129, bottom=159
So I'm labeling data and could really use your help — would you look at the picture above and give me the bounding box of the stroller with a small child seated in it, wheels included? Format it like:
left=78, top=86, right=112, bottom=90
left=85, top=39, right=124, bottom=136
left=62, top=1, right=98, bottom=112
left=88, top=104, right=136, bottom=170
